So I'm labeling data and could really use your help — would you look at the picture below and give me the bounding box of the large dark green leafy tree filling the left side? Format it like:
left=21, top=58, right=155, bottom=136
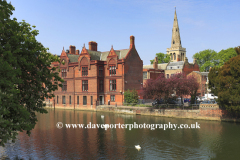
left=0, top=0, right=63, bottom=146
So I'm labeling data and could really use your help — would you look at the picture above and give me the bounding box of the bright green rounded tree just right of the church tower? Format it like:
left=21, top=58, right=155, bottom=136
left=193, top=49, right=219, bottom=72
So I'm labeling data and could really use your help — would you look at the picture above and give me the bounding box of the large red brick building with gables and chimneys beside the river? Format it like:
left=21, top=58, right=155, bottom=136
left=51, top=36, right=143, bottom=109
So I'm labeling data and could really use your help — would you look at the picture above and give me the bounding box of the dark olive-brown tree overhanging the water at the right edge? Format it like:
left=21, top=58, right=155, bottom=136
left=209, top=47, right=240, bottom=116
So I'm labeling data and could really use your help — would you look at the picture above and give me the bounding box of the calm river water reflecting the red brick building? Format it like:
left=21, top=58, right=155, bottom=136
left=0, top=109, right=240, bottom=160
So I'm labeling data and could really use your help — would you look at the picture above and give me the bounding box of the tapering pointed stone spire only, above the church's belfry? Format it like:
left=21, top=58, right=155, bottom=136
left=171, top=7, right=182, bottom=48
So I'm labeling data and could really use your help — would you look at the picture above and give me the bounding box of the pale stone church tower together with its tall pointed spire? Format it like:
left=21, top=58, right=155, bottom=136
left=167, top=8, right=186, bottom=62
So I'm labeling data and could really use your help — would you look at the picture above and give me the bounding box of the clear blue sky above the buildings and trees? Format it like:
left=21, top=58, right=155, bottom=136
left=8, top=0, right=240, bottom=65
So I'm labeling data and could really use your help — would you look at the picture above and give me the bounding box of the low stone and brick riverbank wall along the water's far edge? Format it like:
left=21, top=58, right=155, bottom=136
left=46, top=104, right=240, bottom=122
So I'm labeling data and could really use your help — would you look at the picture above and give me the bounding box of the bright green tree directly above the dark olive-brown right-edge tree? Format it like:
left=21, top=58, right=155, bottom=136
left=217, top=48, right=237, bottom=67
